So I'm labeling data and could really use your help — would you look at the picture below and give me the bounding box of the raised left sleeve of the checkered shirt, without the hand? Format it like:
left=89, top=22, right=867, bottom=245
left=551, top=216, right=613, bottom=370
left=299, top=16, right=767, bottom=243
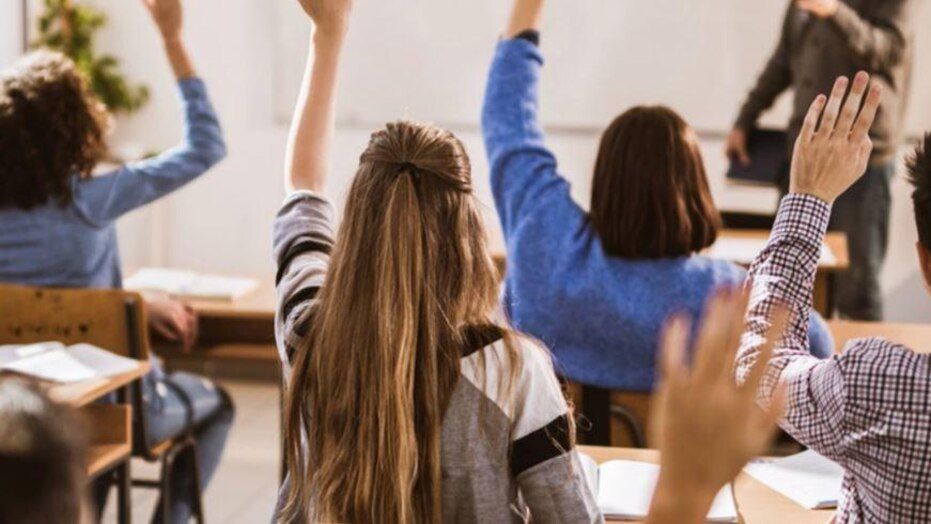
left=737, top=194, right=846, bottom=464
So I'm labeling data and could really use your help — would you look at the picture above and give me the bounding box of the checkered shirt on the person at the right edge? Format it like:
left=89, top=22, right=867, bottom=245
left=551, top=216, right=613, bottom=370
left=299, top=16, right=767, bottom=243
left=737, top=194, right=931, bottom=523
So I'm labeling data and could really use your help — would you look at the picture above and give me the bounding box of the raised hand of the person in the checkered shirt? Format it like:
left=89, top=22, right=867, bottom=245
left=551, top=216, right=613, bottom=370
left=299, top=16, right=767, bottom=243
left=789, top=71, right=882, bottom=204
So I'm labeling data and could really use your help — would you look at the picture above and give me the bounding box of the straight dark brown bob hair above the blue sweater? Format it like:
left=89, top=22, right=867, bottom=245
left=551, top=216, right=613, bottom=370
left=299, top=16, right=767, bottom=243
left=590, top=106, right=721, bottom=259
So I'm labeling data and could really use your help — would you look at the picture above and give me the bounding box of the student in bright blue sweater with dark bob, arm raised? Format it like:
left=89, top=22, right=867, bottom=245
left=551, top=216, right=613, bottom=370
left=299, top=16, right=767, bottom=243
left=482, top=0, right=834, bottom=391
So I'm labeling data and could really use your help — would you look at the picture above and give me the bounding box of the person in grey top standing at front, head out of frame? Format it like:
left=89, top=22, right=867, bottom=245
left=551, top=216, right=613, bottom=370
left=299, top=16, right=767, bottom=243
left=727, top=0, right=920, bottom=320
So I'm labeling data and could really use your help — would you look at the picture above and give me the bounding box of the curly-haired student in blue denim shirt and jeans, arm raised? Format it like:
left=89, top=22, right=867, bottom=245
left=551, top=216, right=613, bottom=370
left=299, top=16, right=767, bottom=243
left=0, top=0, right=233, bottom=522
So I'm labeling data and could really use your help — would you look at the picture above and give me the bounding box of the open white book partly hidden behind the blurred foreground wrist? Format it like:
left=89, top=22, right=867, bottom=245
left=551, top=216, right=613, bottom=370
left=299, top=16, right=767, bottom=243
left=579, top=454, right=737, bottom=522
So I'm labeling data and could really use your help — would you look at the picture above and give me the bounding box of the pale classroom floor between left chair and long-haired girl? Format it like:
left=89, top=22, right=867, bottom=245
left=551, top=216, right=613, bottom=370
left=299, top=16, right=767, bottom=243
left=103, top=380, right=279, bottom=524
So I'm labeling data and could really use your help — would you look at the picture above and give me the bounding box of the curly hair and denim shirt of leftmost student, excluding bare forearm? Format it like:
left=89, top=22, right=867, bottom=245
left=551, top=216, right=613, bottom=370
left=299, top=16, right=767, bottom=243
left=0, top=53, right=225, bottom=288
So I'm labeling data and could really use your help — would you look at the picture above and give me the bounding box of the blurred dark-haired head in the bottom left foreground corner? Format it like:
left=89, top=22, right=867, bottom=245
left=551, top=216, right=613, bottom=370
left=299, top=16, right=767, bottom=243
left=0, top=379, right=86, bottom=524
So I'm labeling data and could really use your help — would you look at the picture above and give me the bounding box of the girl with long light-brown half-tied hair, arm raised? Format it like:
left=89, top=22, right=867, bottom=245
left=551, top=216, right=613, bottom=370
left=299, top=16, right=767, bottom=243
left=274, top=0, right=602, bottom=523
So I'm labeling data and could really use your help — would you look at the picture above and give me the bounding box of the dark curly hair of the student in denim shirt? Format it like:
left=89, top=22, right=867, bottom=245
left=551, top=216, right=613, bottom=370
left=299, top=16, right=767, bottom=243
left=0, top=51, right=109, bottom=210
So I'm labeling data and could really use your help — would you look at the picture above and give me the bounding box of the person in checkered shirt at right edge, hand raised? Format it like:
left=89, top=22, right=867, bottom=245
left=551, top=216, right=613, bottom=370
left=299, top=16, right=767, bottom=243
left=737, top=73, right=931, bottom=522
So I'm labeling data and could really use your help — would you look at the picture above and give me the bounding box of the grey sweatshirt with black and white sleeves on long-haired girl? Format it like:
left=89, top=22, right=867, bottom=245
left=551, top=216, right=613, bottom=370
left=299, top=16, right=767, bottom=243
left=274, top=192, right=603, bottom=523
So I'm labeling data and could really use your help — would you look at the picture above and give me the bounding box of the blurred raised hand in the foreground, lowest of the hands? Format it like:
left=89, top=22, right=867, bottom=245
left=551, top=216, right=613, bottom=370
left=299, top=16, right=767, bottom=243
left=650, top=290, right=787, bottom=522
